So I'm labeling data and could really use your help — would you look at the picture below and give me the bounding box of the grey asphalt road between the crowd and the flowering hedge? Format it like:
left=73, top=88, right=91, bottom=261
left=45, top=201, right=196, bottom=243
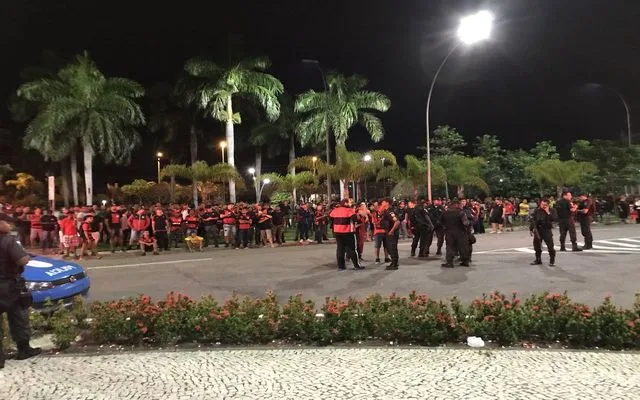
left=82, top=225, right=640, bottom=306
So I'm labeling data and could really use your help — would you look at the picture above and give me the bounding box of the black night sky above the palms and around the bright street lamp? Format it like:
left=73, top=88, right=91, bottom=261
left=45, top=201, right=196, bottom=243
left=0, top=0, right=640, bottom=184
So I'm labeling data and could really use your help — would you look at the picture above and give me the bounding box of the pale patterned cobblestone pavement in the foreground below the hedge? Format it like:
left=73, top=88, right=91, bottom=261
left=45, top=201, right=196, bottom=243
left=0, top=348, right=640, bottom=400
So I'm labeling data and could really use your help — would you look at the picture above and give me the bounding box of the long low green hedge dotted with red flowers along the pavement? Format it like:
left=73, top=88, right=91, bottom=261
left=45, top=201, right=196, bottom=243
left=26, top=292, right=640, bottom=349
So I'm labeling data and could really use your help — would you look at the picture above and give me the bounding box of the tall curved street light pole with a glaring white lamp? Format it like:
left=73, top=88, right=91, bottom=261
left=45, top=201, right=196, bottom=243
left=426, top=11, right=493, bottom=201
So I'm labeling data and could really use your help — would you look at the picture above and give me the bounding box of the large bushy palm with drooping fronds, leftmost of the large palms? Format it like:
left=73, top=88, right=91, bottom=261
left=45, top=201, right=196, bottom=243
left=18, top=52, right=145, bottom=205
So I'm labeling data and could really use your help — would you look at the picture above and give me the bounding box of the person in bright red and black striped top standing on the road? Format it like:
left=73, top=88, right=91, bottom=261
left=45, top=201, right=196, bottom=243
left=329, top=198, right=364, bottom=271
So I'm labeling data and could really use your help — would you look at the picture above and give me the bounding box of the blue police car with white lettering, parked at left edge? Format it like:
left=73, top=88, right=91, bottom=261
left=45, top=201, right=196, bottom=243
left=22, top=255, right=91, bottom=310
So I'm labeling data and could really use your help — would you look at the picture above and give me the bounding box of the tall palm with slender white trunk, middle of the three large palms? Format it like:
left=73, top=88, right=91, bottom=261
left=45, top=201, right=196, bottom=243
left=185, top=57, right=284, bottom=202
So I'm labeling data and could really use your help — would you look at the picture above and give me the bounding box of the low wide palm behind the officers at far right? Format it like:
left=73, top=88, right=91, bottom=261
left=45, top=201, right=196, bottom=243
left=527, top=159, right=597, bottom=198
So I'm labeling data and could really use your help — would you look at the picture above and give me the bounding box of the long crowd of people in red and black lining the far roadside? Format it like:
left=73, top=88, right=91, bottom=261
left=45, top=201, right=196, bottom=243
left=0, top=195, right=640, bottom=268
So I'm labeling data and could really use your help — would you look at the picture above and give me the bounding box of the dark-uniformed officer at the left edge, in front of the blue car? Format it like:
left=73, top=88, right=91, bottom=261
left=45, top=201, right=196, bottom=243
left=0, top=221, right=41, bottom=368
